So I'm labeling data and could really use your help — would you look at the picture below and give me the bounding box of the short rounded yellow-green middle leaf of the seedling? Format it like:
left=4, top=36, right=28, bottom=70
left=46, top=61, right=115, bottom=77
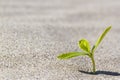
left=79, top=39, right=90, bottom=52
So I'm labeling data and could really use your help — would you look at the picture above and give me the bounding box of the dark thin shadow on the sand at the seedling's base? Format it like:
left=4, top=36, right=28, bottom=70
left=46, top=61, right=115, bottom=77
left=79, top=70, right=120, bottom=76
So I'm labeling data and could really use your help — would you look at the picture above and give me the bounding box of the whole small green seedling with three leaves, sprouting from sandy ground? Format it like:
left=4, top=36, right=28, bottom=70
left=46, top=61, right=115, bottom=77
left=58, top=26, right=111, bottom=73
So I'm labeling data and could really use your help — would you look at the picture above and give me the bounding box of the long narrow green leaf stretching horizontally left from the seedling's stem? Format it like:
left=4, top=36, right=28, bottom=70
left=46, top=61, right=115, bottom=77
left=58, top=52, right=88, bottom=59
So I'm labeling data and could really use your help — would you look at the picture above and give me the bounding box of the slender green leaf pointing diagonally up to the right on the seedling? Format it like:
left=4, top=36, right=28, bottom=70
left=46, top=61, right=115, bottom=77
left=92, top=26, right=112, bottom=51
